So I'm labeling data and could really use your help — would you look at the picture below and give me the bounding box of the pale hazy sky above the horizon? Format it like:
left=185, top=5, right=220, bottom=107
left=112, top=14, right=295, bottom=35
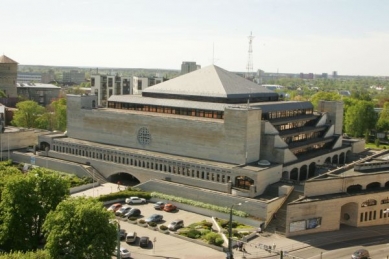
left=0, top=0, right=389, bottom=76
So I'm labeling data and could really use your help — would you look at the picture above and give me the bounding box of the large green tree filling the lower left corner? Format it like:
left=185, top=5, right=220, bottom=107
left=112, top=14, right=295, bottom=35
left=0, top=168, right=69, bottom=251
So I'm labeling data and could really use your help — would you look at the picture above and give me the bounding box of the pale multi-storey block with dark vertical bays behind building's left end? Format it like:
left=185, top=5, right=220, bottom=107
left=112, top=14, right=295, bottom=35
left=91, top=74, right=132, bottom=107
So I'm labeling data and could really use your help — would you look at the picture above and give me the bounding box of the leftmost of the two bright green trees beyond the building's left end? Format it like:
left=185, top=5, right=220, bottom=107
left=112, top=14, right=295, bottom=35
left=11, top=101, right=45, bottom=128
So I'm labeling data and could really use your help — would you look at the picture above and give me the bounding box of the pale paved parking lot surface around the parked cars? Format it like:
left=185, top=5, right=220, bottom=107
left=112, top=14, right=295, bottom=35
left=107, top=203, right=225, bottom=259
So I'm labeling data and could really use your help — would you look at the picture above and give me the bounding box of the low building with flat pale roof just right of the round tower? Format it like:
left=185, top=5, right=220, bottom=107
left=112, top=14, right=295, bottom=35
left=17, top=83, right=61, bottom=106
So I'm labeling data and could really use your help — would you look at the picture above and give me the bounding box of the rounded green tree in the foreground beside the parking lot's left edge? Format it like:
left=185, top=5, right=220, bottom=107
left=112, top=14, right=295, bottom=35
left=43, top=197, right=117, bottom=259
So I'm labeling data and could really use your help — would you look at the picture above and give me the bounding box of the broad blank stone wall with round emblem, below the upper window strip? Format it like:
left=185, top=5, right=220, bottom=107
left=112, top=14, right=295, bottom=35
left=67, top=95, right=261, bottom=164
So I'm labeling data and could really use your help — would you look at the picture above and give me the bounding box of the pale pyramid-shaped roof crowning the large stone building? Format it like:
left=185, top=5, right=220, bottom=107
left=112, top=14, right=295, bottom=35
left=142, top=65, right=278, bottom=99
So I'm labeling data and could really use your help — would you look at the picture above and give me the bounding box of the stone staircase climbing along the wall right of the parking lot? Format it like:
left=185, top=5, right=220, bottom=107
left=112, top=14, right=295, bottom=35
left=266, top=189, right=304, bottom=235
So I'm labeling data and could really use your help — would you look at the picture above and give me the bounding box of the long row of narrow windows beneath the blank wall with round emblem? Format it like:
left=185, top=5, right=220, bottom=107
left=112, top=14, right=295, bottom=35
left=53, top=143, right=235, bottom=185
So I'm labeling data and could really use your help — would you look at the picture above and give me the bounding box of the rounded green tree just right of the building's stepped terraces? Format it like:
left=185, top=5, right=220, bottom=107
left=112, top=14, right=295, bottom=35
left=345, top=101, right=377, bottom=137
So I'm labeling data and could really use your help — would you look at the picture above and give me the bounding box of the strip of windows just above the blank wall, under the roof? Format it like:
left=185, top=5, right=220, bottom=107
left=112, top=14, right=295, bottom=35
left=108, top=102, right=224, bottom=119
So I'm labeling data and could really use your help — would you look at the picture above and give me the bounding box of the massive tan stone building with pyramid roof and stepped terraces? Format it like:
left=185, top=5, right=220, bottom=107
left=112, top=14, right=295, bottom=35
left=31, top=65, right=363, bottom=232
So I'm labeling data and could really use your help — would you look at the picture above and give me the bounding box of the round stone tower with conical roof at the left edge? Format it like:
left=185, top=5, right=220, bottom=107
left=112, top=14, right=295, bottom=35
left=0, top=55, right=18, bottom=97
